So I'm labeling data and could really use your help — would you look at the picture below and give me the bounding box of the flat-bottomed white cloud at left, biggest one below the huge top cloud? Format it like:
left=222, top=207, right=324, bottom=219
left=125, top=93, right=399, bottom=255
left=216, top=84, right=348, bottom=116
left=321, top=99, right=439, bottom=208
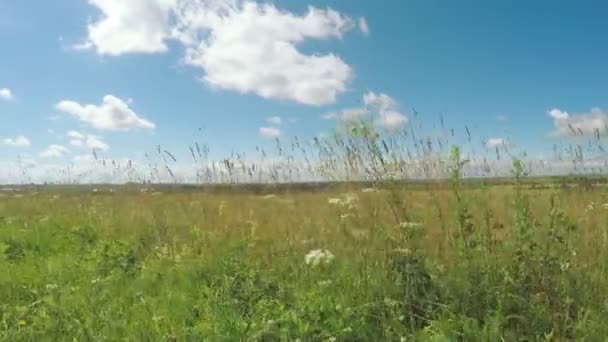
left=55, top=95, right=155, bottom=131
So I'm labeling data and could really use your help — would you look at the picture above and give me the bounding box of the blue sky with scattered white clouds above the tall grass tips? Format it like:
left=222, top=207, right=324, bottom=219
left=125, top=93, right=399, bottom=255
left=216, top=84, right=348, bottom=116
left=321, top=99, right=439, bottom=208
left=0, top=0, right=608, bottom=181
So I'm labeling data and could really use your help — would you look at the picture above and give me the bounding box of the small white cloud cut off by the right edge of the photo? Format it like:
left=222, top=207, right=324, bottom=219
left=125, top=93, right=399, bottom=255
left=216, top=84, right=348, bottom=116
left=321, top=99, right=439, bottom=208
left=547, top=108, right=608, bottom=137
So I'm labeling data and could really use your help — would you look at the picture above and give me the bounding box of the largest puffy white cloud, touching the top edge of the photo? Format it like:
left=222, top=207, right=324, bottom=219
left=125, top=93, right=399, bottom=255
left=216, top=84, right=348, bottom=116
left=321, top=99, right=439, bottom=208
left=80, top=0, right=355, bottom=106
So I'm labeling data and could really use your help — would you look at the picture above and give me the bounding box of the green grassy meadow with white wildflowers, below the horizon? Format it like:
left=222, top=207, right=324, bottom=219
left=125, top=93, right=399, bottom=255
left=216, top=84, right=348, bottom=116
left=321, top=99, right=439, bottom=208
left=0, top=181, right=608, bottom=341
